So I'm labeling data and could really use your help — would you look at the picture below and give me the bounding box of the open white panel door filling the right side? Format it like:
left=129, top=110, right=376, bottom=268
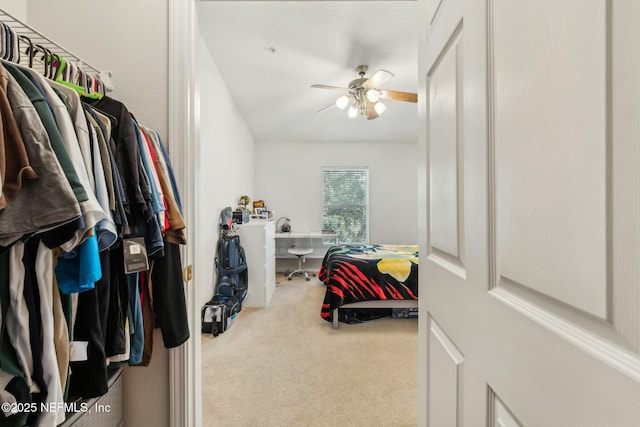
left=418, top=0, right=640, bottom=427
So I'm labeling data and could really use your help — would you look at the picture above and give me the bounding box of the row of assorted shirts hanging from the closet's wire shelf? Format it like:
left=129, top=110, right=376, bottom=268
left=0, top=23, right=190, bottom=426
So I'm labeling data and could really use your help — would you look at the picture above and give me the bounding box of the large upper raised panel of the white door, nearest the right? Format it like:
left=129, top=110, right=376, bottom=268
left=489, top=0, right=607, bottom=318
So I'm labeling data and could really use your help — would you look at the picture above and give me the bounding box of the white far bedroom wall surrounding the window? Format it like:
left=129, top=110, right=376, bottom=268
left=252, top=142, right=418, bottom=244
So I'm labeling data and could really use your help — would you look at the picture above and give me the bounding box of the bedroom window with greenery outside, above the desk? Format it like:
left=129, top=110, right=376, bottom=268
left=322, top=167, right=369, bottom=243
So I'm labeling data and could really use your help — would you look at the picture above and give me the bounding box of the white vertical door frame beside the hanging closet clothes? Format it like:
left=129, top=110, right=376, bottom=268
left=168, top=0, right=202, bottom=427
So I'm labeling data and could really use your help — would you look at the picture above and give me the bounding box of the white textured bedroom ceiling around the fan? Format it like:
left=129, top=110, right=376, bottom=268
left=198, top=1, right=418, bottom=143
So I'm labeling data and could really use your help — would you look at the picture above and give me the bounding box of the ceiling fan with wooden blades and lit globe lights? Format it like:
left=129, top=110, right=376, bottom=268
left=311, top=65, right=418, bottom=120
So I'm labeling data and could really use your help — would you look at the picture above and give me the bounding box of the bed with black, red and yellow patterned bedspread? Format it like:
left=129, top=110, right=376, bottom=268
left=318, top=244, right=418, bottom=329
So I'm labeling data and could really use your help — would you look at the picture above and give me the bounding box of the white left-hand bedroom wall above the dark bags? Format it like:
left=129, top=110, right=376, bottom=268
left=194, top=30, right=255, bottom=310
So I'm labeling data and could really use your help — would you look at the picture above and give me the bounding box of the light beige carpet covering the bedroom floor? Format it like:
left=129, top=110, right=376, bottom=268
left=201, top=274, right=418, bottom=427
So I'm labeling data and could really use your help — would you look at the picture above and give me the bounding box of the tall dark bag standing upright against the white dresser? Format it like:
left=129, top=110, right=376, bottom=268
left=215, top=233, right=249, bottom=309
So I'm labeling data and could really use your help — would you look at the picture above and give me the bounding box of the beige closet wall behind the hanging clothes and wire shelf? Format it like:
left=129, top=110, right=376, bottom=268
left=27, top=0, right=170, bottom=427
